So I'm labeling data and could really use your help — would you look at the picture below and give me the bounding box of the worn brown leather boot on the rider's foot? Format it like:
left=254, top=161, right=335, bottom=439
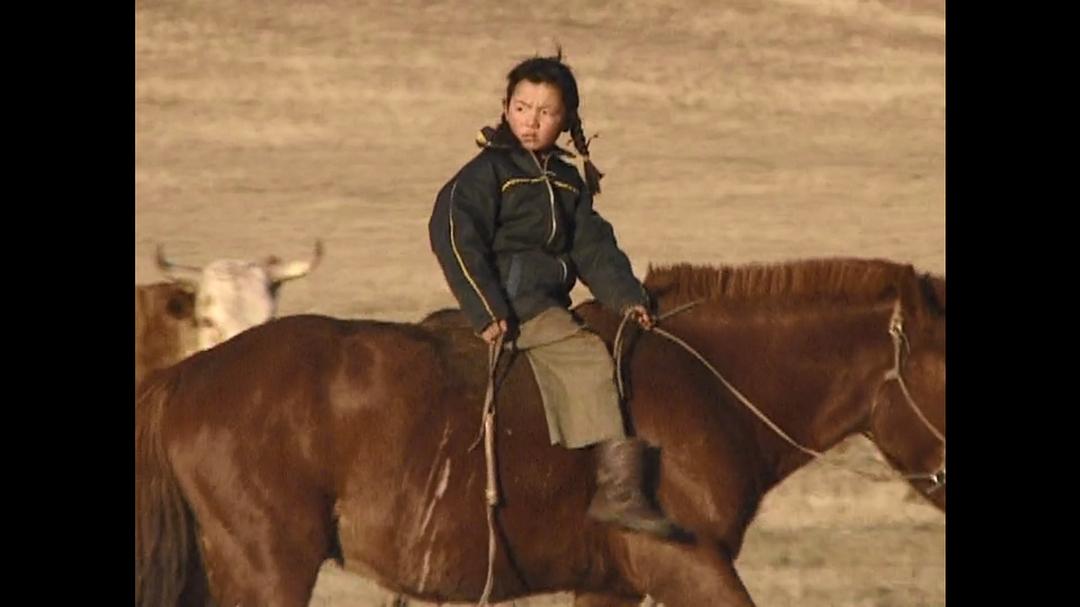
left=589, top=439, right=677, bottom=538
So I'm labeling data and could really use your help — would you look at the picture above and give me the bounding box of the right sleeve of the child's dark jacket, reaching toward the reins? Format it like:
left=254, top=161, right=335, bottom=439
left=570, top=187, right=649, bottom=314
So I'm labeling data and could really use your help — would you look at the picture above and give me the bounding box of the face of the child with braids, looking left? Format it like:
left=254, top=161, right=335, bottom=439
left=503, top=80, right=566, bottom=151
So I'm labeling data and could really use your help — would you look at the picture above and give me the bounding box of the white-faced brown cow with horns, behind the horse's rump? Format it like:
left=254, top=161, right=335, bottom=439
left=135, top=241, right=323, bottom=386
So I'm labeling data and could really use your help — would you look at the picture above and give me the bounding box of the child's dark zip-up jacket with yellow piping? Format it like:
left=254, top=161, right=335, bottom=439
left=428, top=123, right=648, bottom=332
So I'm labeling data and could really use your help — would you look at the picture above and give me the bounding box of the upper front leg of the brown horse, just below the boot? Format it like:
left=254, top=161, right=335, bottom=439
left=621, top=536, right=754, bottom=607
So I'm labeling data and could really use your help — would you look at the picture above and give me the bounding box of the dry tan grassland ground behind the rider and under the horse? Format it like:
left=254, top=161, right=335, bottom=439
left=134, top=0, right=945, bottom=607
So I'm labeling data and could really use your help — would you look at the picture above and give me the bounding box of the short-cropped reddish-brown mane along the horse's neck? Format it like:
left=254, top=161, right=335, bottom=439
left=644, top=258, right=945, bottom=315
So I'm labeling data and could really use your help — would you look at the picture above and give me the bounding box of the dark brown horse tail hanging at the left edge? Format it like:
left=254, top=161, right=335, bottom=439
left=135, top=372, right=205, bottom=607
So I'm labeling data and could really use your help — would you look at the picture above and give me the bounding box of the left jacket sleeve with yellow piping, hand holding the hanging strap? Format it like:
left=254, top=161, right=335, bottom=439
left=428, top=156, right=510, bottom=333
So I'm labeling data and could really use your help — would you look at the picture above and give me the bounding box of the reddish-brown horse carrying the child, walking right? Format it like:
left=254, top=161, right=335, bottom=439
left=135, top=259, right=945, bottom=607
